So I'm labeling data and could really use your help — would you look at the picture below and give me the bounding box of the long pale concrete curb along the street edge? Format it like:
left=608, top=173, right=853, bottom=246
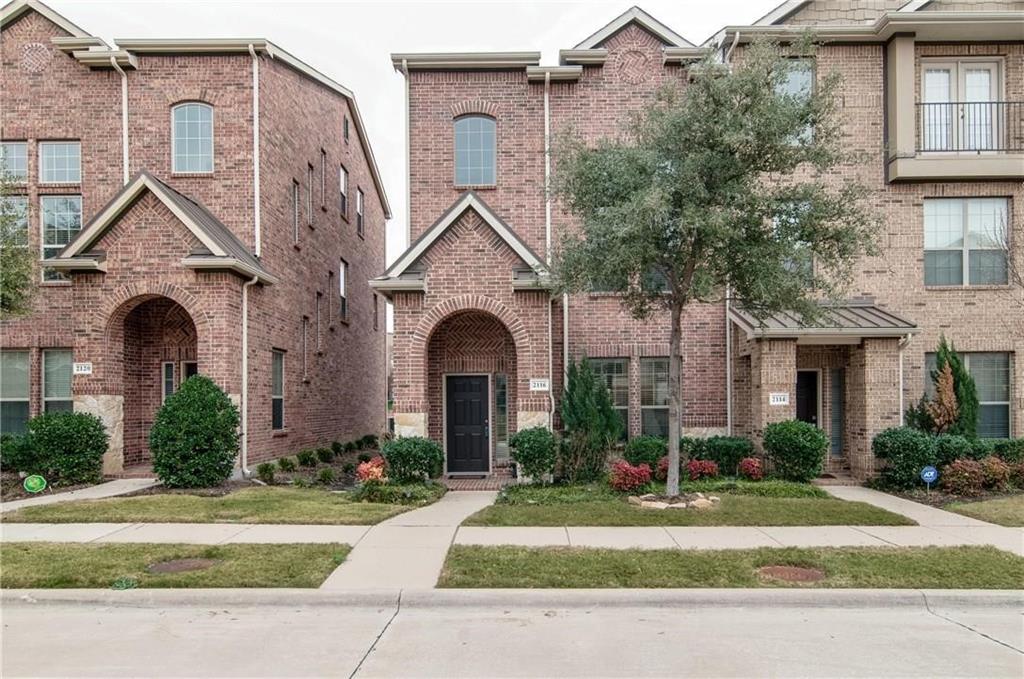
left=0, top=589, right=1024, bottom=609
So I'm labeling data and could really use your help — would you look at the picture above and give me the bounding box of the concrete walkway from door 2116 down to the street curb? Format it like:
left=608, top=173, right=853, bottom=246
left=321, top=491, right=498, bottom=590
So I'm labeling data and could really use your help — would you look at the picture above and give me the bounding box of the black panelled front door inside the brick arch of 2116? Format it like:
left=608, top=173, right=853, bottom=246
left=444, top=375, right=490, bottom=474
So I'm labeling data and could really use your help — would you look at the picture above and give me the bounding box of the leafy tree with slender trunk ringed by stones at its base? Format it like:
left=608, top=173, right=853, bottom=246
left=553, top=39, right=877, bottom=495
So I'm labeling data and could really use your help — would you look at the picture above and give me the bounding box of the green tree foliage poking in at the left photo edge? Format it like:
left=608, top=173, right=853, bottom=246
left=0, top=169, right=37, bottom=319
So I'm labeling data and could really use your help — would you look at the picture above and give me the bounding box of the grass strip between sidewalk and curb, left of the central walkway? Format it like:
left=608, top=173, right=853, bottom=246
left=0, top=543, right=350, bottom=589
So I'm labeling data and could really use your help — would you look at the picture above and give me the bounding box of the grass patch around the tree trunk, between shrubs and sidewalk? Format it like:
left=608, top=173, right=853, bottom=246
left=463, top=481, right=914, bottom=526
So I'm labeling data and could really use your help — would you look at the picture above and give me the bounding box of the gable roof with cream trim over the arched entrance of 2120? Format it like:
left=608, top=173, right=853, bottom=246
left=54, top=171, right=278, bottom=284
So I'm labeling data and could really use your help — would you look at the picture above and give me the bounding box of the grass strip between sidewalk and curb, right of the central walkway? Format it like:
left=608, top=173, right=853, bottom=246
left=437, top=545, right=1024, bottom=589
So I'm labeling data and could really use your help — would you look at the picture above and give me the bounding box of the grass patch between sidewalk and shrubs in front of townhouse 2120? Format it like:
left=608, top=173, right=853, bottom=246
left=3, top=487, right=423, bottom=524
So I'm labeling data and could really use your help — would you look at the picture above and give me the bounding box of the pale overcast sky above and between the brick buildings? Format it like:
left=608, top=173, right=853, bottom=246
left=46, top=0, right=779, bottom=262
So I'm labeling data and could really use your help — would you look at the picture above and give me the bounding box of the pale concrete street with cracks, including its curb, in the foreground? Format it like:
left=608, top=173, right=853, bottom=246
left=2, top=590, right=1024, bottom=677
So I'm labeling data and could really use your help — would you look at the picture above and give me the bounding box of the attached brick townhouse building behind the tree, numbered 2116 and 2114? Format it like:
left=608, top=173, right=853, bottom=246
left=372, top=0, right=1024, bottom=478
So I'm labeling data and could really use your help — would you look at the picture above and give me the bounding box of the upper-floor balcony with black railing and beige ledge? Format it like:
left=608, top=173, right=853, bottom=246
left=889, top=101, right=1024, bottom=181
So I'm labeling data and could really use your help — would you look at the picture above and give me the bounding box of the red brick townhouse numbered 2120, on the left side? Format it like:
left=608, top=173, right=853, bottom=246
left=0, top=0, right=390, bottom=473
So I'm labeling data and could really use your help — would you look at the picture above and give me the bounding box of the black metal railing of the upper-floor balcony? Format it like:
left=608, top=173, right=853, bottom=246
left=918, top=101, right=1024, bottom=153
